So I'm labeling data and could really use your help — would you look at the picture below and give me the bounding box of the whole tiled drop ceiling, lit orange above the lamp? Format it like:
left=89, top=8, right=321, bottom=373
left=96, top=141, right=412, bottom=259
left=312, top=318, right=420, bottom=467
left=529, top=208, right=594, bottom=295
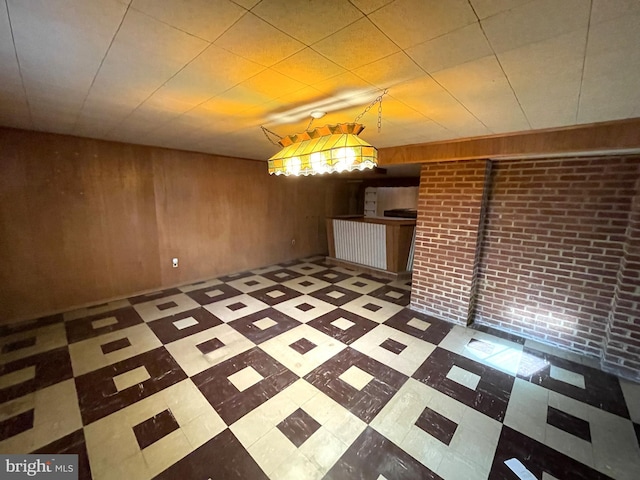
left=0, top=0, right=640, bottom=160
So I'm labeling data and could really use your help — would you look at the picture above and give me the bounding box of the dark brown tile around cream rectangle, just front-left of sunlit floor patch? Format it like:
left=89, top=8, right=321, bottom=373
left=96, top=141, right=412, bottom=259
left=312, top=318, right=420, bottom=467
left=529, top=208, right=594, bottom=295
left=412, top=348, right=514, bottom=422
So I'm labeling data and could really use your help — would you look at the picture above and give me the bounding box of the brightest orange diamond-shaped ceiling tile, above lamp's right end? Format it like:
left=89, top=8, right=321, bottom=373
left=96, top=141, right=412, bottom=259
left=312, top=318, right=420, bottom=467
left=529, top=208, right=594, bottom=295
left=313, top=18, right=399, bottom=70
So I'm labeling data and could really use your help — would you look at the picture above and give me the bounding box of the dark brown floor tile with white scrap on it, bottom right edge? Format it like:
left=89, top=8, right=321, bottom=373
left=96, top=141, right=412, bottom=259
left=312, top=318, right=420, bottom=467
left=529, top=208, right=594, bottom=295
left=489, top=425, right=610, bottom=480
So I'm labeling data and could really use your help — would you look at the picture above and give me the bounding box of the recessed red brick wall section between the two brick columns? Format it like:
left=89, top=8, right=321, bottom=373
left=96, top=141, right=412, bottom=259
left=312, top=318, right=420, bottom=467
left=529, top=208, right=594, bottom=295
left=475, top=158, right=639, bottom=356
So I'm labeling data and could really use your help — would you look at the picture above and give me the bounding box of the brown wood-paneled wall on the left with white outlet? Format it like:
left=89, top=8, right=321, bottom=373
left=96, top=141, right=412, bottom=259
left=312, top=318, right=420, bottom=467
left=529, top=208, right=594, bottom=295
left=0, top=129, right=351, bottom=323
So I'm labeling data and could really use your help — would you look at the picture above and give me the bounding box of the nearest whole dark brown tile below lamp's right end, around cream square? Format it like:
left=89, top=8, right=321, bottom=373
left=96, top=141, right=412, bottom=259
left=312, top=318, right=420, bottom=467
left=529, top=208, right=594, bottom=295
left=304, top=347, right=407, bottom=423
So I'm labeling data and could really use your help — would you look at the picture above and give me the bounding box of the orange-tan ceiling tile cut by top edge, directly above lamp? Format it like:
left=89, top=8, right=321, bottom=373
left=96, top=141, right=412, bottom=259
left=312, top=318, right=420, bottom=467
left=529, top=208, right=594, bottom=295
left=252, top=0, right=363, bottom=45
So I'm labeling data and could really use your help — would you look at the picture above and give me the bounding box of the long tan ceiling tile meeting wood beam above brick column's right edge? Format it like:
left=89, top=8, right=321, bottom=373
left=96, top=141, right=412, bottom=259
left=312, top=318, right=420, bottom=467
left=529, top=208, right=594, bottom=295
left=434, top=56, right=530, bottom=133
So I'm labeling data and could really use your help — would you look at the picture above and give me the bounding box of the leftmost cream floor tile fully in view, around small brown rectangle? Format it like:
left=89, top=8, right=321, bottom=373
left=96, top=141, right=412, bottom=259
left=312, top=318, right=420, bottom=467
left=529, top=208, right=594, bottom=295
left=69, top=324, right=162, bottom=377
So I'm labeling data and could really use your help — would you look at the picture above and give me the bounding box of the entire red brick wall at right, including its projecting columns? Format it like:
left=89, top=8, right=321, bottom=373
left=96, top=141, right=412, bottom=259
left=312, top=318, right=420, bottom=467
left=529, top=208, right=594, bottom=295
left=411, top=156, right=640, bottom=378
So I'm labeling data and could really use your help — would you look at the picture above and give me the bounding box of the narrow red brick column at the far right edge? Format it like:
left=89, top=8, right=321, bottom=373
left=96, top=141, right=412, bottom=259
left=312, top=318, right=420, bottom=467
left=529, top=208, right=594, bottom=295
left=602, top=174, right=640, bottom=380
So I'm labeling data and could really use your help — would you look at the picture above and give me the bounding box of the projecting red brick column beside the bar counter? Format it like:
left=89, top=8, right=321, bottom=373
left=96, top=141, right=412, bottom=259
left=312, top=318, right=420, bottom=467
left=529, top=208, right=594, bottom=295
left=411, top=160, right=491, bottom=325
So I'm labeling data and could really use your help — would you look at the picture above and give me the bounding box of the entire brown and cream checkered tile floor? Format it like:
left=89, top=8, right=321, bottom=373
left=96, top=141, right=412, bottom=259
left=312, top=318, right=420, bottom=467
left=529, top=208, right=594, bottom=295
left=0, top=258, right=640, bottom=480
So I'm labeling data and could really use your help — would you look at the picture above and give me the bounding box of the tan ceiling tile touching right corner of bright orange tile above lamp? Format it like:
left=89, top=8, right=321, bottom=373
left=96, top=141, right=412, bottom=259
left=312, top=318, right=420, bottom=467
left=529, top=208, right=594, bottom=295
left=406, top=23, right=492, bottom=73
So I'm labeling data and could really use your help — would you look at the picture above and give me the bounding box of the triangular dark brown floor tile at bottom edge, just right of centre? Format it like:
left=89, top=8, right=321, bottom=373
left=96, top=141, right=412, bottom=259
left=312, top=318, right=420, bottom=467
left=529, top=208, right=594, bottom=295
left=324, top=427, right=442, bottom=480
